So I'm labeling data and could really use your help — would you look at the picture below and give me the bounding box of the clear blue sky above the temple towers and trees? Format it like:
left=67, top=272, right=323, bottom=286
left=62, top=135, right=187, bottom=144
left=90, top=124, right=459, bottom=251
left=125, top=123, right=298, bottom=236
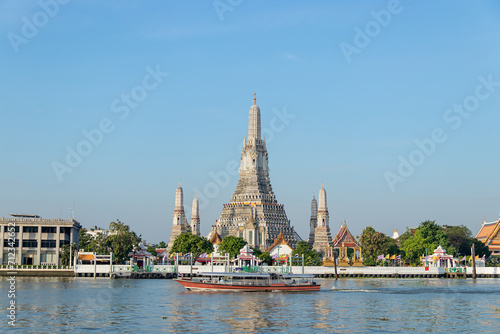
left=0, top=0, right=500, bottom=242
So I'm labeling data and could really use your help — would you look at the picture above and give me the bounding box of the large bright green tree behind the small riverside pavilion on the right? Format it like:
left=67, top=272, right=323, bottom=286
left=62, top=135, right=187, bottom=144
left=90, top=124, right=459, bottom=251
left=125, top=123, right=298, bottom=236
left=401, top=220, right=455, bottom=266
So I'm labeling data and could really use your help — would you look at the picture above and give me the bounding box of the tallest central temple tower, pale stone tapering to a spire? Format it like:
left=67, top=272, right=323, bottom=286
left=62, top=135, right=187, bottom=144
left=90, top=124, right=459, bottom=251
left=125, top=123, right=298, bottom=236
left=210, top=94, right=297, bottom=250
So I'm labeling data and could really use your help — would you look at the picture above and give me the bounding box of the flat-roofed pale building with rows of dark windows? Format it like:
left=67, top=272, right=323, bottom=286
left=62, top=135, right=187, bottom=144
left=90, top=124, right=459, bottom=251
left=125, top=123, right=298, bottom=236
left=0, top=214, right=82, bottom=265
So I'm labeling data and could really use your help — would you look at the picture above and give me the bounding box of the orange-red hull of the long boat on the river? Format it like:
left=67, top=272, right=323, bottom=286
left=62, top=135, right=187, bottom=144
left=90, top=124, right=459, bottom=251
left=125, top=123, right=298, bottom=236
left=176, top=279, right=321, bottom=292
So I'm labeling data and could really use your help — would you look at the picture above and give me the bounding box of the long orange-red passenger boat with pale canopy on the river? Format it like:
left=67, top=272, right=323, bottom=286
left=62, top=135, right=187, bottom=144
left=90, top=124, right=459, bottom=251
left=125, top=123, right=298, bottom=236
left=177, top=272, right=321, bottom=292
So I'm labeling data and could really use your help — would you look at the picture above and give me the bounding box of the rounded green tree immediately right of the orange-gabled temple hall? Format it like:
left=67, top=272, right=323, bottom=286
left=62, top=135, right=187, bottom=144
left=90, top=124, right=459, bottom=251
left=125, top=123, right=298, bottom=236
left=359, top=226, right=399, bottom=266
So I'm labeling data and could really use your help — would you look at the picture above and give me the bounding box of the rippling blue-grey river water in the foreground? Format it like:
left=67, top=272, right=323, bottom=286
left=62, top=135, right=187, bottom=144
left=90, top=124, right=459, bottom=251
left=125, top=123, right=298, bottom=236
left=0, top=277, right=500, bottom=333
